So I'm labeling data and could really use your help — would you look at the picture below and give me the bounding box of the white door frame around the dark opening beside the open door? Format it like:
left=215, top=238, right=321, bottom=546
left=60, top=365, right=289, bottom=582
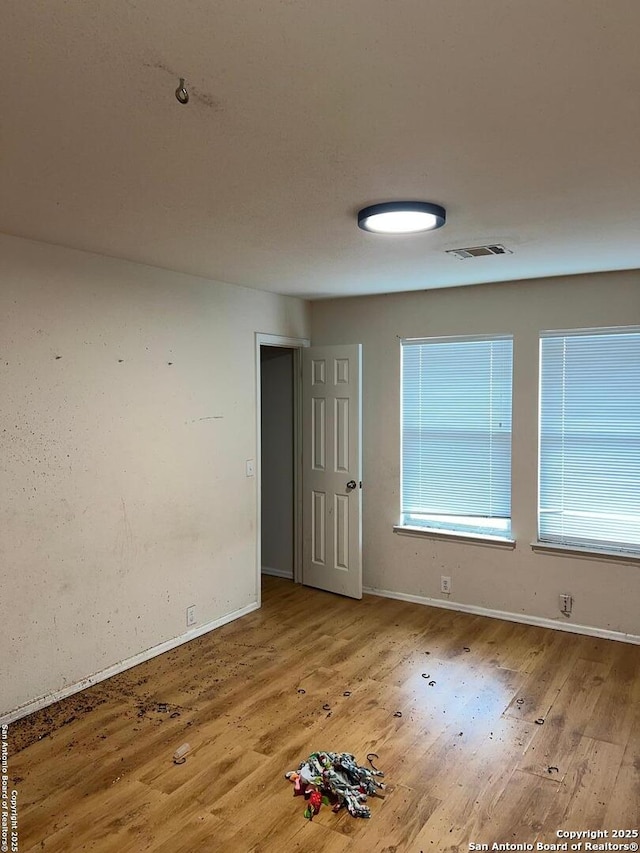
left=255, top=332, right=311, bottom=606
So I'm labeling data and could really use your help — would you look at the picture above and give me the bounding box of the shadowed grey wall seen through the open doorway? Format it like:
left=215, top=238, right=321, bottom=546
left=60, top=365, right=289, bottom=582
left=261, top=347, right=294, bottom=578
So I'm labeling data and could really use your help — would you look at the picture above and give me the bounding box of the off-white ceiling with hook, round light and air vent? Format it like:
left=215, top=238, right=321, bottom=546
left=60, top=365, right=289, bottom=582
left=0, top=0, right=640, bottom=298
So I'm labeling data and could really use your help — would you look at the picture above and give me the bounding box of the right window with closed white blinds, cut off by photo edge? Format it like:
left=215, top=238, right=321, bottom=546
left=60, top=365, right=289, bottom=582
left=538, top=328, right=640, bottom=553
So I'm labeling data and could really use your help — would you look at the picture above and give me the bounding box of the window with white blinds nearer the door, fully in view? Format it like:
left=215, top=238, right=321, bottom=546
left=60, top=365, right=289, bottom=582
left=400, top=337, right=513, bottom=539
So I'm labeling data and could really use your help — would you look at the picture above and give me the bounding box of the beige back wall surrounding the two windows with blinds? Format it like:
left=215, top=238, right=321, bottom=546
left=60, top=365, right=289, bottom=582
left=311, top=270, right=640, bottom=635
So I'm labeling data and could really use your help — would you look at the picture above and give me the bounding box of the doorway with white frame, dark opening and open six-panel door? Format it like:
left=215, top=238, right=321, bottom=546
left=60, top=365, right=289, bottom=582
left=256, top=333, right=362, bottom=604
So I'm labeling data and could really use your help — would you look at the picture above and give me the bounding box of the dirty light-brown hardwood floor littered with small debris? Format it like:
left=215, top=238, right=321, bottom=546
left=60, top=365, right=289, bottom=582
left=9, top=578, right=640, bottom=853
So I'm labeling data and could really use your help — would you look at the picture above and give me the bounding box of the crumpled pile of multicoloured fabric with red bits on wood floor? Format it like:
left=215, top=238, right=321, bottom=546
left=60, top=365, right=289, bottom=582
left=285, top=752, right=385, bottom=820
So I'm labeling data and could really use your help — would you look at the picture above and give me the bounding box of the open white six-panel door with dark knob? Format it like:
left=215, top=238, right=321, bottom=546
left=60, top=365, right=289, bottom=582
left=302, top=344, right=362, bottom=598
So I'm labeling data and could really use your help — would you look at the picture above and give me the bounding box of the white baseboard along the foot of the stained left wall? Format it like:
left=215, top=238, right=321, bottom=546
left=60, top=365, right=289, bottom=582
left=0, top=601, right=260, bottom=725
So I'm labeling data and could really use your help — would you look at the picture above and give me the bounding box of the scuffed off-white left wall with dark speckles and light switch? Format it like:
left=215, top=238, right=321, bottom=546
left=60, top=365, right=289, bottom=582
left=0, top=236, right=308, bottom=715
